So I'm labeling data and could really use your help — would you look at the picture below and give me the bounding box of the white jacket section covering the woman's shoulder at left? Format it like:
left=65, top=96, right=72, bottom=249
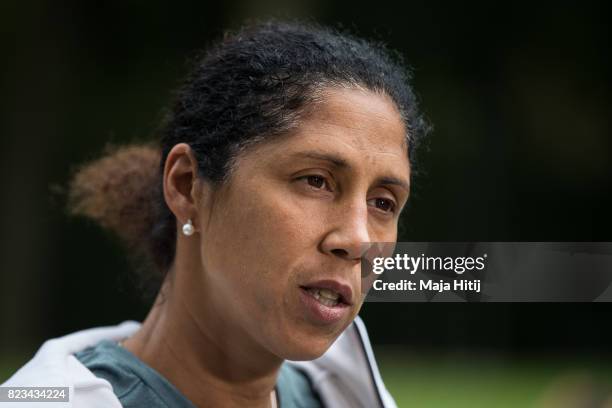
left=2, top=321, right=140, bottom=408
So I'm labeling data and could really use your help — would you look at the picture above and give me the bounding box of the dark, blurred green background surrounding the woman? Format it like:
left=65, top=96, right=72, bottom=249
left=0, top=0, right=612, bottom=407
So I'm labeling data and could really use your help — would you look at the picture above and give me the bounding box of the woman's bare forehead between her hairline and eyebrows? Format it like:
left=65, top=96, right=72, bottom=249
left=251, top=88, right=410, bottom=177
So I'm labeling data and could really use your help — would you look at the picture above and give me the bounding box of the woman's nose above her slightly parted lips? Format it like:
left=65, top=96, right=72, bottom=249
left=321, top=200, right=372, bottom=261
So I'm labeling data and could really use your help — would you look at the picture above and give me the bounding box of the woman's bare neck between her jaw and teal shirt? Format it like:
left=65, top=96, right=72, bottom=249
left=124, top=262, right=283, bottom=408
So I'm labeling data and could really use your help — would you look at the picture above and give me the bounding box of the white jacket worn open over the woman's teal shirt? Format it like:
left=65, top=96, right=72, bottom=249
left=3, top=317, right=396, bottom=408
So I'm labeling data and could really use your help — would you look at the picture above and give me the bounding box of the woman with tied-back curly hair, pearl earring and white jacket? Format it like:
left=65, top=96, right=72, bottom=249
left=5, top=19, right=425, bottom=408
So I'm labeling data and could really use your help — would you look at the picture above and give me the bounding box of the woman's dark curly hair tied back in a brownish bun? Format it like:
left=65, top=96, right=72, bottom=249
left=69, top=22, right=428, bottom=302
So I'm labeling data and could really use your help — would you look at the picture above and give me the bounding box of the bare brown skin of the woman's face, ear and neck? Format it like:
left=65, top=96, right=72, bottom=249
left=124, top=88, right=410, bottom=407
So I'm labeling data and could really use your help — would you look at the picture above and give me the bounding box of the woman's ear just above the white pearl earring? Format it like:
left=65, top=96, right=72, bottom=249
left=163, top=143, right=201, bottom=226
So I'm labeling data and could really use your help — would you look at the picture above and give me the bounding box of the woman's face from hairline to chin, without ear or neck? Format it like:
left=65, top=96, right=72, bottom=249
left=197, top=89, right=410, bottom=360
